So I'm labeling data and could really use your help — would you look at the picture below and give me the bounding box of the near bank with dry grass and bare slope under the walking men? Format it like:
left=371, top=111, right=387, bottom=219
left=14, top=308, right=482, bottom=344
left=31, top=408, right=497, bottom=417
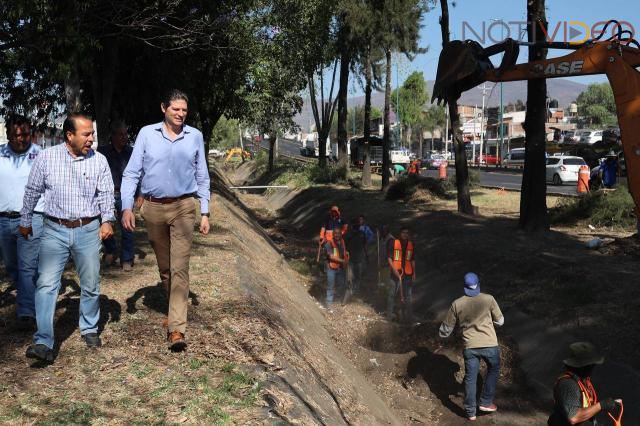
left=0, top=166, right=397, bottom=425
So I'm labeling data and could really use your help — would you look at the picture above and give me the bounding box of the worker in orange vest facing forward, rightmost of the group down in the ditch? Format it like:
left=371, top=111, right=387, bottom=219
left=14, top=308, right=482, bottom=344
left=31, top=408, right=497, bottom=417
left=387, top=227, right=416, bottom=322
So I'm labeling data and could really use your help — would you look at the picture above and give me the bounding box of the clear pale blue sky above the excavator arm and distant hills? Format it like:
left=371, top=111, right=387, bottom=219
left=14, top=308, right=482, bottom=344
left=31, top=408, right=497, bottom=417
left=354, top=0, right=640, bottom=96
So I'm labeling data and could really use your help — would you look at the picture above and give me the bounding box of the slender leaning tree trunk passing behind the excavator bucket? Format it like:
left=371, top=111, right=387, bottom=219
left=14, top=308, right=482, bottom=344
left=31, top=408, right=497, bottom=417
left=440, top=0, right=475, bottom=215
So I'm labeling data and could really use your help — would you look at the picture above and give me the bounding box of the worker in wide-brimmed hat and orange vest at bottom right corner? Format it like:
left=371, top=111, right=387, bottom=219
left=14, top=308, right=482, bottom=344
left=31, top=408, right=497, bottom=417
left=547, top=342, right=622, bottom=426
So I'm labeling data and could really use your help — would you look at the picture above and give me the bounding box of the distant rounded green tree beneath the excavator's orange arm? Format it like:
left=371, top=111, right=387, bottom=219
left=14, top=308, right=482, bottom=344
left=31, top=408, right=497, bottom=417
left=577, top=83, right=617, bottom=127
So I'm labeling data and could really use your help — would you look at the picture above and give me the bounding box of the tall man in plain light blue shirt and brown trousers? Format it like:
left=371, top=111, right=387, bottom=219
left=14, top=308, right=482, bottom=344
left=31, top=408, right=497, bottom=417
left=121, top=90, right=210, bottom=351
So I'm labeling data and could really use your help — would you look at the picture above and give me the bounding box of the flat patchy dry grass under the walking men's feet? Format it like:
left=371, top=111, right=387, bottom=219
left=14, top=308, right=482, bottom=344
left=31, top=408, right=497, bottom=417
left=0, top=211, right=268, bottom=425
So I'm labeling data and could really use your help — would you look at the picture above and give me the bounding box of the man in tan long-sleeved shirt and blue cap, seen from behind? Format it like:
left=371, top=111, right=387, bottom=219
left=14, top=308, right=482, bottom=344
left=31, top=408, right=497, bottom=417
left=439, top=272, right=504, bottom=420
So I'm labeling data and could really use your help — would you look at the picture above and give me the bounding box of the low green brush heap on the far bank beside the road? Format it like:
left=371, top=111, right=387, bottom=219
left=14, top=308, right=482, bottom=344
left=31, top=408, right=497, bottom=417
left=550, top=186, right=636, bottom=229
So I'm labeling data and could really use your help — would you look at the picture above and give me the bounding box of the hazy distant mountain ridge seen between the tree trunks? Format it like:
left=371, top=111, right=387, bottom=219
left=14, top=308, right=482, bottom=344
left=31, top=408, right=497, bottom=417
left=294, top=78, right=587, bottom=129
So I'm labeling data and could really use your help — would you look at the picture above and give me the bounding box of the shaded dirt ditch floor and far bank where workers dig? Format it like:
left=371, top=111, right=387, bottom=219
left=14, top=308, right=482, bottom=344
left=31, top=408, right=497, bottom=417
left=231, top=165, right=640, bottom=424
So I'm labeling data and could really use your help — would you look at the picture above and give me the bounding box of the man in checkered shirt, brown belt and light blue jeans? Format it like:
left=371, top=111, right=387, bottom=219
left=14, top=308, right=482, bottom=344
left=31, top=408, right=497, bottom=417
left=20, top=114, right=115, bottom=362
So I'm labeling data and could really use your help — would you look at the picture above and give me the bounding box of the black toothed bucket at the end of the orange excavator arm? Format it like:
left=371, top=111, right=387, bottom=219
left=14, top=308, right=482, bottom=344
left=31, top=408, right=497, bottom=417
left=431, top=39, right=519, bottom=104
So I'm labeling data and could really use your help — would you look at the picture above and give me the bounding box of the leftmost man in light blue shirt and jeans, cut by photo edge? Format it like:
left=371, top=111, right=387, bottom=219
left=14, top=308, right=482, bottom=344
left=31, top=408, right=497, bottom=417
left=0, top=115, right=44, bottom=331
